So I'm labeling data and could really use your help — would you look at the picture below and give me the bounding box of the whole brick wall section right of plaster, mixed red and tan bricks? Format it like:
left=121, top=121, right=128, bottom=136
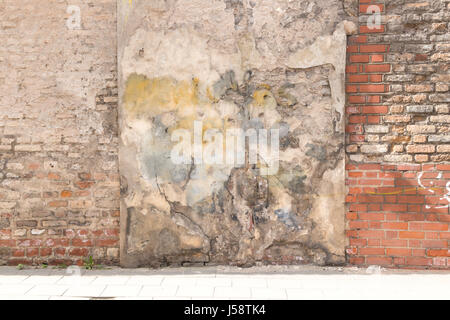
left=347, top=0, right=450, bottom=268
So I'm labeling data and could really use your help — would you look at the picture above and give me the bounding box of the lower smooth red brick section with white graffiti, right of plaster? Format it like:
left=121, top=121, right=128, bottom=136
left=347, top=164, right=450, bottom=267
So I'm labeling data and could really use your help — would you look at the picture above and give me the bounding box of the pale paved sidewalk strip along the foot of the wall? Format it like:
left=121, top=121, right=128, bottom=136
left=0, top=266, right=450, bottom=300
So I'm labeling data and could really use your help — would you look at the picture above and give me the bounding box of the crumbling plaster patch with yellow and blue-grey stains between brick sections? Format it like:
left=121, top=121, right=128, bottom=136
left=119, top=0, right=354, bottom=267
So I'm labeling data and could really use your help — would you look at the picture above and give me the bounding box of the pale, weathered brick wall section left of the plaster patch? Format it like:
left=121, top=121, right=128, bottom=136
left=0, top=0, right=119, bottom=265
